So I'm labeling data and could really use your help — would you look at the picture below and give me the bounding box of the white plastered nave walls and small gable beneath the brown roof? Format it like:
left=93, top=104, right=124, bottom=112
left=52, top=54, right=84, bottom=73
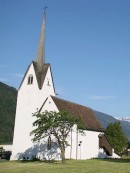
left=41, top=97, right=107, bottom=160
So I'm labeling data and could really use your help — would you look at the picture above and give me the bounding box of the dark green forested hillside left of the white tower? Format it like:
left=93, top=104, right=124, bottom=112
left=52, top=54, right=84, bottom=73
left=0, top=82, right=17, bottom=143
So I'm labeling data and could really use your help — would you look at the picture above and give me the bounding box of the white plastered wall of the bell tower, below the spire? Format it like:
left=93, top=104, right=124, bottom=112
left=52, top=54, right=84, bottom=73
left=11, top=64, right=55, bottom=160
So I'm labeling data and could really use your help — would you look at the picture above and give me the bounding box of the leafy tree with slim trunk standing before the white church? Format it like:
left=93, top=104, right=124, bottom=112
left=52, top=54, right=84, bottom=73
left=31, top=111, right=84, bottom=163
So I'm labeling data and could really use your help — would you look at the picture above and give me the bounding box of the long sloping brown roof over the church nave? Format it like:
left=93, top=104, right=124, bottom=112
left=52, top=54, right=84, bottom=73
left=51, top=96, right=104, bottom=131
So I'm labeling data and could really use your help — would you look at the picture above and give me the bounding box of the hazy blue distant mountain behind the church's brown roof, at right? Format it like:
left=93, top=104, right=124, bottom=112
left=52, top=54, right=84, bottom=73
left=93, top=110, right=130, bottom=141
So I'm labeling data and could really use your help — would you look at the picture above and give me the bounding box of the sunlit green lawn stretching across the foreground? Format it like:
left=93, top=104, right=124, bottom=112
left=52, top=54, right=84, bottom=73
left=0, top=159, right=130, bottom=173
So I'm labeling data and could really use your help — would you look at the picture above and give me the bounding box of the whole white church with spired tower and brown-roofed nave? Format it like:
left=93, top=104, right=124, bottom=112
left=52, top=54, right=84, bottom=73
left=11, top=12, right=119, bottom=160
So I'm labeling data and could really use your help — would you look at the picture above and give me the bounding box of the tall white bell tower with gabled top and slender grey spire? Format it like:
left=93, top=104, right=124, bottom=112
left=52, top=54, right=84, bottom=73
left=11, top=7, right=55, bottom=160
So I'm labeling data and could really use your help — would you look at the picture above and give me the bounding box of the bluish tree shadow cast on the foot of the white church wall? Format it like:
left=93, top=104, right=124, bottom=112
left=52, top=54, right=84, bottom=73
left=17, top=142, right=61, bottom=160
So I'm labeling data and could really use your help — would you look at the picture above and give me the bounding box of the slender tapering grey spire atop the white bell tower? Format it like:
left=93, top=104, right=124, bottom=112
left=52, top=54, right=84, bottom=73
left=36, top=6, right=47, bottom=71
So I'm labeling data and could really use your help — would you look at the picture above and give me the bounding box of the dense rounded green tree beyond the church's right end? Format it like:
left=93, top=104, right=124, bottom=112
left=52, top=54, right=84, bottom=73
left=105, top=122, right=128, bottom=155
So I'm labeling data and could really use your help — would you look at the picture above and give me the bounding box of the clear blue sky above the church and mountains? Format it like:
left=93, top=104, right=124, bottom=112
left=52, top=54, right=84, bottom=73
left=0, top=0, right=130, bottom=117
